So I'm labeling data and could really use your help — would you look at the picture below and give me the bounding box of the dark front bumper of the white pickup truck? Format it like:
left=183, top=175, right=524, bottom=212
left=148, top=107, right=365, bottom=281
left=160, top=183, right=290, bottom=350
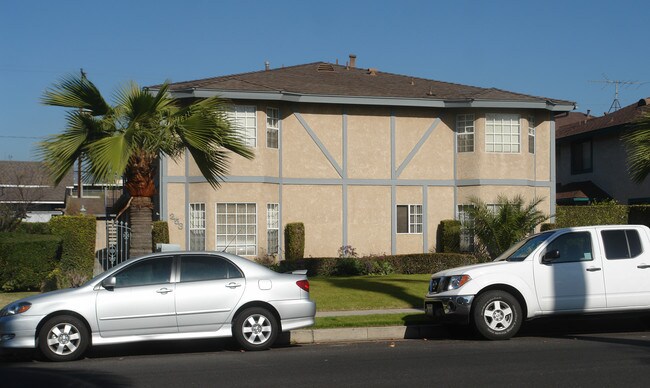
left=424, top=294, right=474, bottom=324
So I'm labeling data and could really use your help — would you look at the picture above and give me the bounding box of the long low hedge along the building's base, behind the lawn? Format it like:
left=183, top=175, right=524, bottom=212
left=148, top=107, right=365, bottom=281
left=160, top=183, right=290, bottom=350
left=275, top=253, right=478, bottom=276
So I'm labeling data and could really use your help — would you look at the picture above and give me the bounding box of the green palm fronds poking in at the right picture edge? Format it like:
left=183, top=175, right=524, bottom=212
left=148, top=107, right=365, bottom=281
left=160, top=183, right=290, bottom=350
left=621, top=112, right=650, bottom=183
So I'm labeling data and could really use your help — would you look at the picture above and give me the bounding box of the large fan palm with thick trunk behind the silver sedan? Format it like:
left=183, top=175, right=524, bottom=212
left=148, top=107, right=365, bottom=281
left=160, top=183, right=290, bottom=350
left=38, top=75, right=254, bottom=256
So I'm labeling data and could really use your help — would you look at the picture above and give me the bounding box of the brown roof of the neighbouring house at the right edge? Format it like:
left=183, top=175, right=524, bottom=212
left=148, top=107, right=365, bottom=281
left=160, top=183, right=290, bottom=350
left=555, top=97, right=650, bottom=139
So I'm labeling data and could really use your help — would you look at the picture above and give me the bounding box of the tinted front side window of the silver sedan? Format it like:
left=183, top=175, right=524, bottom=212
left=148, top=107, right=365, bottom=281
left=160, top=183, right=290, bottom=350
left=115, top=257, right=173, bottom=287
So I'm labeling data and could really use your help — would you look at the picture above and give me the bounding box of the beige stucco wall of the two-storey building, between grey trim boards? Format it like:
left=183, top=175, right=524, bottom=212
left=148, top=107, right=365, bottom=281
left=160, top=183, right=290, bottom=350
left=163, top=102, right=551, bottom=257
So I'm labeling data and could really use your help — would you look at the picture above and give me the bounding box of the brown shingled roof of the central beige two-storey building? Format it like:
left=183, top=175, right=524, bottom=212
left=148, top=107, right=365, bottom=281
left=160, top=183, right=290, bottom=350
left=157, top=62, right=574, bottom=105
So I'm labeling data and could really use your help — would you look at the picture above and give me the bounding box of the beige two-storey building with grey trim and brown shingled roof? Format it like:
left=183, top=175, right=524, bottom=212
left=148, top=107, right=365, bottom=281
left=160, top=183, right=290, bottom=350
left=150, top=56, right=574, bottom=257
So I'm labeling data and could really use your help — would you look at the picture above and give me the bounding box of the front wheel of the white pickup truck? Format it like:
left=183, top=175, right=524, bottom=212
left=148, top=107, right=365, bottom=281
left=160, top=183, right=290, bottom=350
left=472, top=290, right=522, bottom=340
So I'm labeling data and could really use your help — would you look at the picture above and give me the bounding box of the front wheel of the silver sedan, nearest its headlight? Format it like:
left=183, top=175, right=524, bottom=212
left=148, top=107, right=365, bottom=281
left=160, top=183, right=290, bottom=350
left=38, top=315, right=90, bottom=361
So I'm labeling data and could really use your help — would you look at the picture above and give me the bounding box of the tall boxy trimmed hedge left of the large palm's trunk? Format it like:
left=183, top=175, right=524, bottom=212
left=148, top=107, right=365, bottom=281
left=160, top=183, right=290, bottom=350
left=50, top=216, right=97, bottom=288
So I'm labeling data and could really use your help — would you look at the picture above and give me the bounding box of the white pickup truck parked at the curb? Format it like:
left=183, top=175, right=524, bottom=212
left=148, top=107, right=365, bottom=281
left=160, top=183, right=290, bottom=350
left=424, top=225, right=650, bottom=340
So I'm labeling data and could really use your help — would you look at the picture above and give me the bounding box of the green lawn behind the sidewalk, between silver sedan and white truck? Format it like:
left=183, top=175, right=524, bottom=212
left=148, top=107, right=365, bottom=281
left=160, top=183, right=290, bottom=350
left=309, top=275, right=431, bottom=311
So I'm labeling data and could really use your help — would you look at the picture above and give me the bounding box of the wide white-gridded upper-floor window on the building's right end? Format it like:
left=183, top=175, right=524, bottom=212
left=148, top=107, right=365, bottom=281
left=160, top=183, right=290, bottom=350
left=485, top=113, right=521, bottom=154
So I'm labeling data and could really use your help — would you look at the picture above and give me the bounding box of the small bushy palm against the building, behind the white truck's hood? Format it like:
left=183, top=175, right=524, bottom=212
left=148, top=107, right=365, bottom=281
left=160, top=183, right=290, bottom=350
left=468, top=195, right=548, bottom=259
